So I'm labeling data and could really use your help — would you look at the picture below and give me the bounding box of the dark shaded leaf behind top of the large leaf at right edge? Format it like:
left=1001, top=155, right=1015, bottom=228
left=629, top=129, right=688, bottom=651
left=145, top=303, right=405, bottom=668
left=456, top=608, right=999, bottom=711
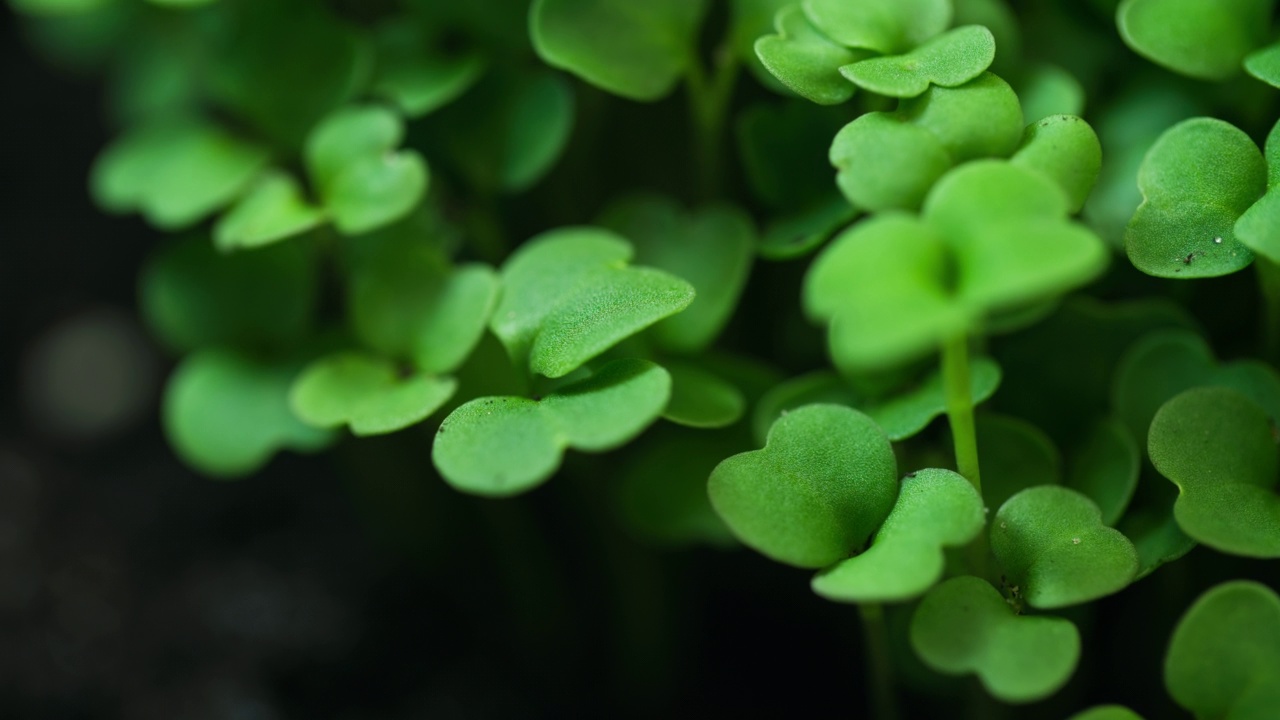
left=1112, top=331, right=1280, bottom=438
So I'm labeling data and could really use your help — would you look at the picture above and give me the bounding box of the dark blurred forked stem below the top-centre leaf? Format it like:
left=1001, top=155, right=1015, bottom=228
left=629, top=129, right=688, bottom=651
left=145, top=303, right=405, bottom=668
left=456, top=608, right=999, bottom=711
left=685, top=44, right=737, bottom=200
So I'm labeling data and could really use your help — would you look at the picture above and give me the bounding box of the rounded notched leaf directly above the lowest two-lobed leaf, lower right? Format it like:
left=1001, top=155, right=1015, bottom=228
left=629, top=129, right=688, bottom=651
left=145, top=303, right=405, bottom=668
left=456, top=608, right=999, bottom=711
left=991, top=486, right=1138, bottom=609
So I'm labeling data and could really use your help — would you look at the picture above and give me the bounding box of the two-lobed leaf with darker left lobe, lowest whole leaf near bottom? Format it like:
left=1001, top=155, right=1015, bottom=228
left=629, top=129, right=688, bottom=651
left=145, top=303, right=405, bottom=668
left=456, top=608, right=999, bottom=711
left=911, top=577, right=1080, bottom=702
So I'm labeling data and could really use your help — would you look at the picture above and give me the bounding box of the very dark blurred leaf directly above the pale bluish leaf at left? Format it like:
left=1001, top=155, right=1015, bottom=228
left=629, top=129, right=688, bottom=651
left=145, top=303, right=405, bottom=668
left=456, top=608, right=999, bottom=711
left=140, top=236, right=319, bottom=352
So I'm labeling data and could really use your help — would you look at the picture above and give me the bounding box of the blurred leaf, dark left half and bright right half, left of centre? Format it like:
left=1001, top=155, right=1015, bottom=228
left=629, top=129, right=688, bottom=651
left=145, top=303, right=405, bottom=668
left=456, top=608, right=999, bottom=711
left=347, top=232, right=498, bottom=373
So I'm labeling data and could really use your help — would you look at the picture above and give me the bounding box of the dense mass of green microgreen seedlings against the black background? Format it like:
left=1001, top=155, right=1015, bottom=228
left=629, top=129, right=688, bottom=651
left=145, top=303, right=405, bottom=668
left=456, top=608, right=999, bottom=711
left=10, top=0, right=1280, bottom=720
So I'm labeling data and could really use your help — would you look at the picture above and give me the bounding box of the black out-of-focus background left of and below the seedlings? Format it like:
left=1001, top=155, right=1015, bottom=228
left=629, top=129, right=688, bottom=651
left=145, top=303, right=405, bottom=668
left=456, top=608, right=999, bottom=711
left=0, top=4, right=1275, bottom=720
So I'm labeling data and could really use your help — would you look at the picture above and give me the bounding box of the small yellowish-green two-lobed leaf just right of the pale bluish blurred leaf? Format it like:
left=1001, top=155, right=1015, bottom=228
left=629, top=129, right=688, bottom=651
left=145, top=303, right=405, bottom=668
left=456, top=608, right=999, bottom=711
left=289, top=352, right=457, bottom=436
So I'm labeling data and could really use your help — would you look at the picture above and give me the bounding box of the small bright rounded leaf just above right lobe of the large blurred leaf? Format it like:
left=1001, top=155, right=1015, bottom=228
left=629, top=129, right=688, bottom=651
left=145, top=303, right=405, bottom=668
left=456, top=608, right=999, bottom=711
left=1010, top=115, right=1102, bottom=214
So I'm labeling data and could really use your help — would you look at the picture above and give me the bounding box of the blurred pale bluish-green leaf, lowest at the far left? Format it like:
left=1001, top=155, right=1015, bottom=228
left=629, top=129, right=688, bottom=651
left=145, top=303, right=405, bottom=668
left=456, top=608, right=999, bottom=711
left=163, top=350, right=333, bottom=478
